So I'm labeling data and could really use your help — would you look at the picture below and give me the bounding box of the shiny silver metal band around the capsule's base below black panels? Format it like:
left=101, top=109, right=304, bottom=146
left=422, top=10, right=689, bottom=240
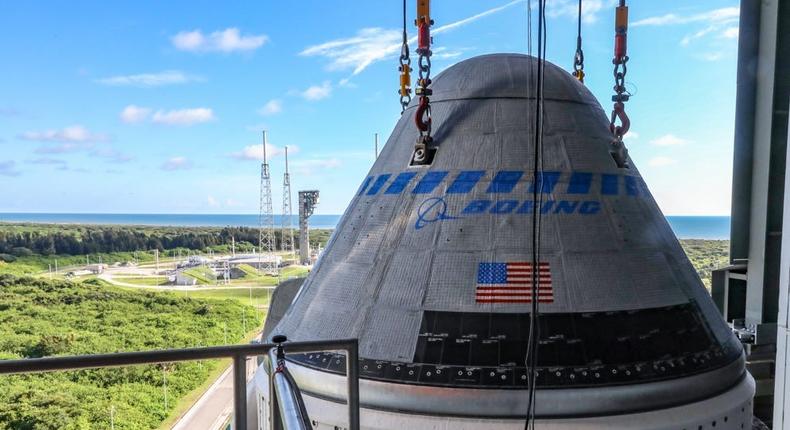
left=288, top=361, right=745, bottom=418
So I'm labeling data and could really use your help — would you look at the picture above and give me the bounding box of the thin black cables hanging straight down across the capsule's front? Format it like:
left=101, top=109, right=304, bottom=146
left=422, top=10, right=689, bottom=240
left=524, top=0, right=547, bottom=429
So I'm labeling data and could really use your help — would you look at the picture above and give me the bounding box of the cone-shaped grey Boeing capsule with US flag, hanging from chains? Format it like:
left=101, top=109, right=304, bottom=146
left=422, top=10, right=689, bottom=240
left=256, top=54, right=754, bottom=430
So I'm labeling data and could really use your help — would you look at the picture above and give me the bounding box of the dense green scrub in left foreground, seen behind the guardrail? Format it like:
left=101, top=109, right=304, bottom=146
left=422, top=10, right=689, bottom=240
left=0, top=275, right=262, bottom=430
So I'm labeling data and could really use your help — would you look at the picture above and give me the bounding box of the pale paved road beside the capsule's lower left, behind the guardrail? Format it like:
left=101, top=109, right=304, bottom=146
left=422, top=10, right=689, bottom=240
left=172, top=357, right=256, bottom=430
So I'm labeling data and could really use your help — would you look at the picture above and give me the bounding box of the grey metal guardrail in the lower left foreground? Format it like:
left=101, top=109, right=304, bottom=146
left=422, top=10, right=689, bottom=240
left=0, top=339, right=359, bottom=430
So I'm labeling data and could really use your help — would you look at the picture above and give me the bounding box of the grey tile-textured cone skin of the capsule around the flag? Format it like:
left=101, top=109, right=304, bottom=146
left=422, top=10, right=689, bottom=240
left=276, top=54, right=742, bottom=414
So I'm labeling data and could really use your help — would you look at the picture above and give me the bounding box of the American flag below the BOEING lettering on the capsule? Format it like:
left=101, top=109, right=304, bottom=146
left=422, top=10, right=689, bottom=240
left=475, top=262, right=554, bottom=303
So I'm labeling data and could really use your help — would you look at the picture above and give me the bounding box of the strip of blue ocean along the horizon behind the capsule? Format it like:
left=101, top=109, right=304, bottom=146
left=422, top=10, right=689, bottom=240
left=0, top=213, right=730, bottom=240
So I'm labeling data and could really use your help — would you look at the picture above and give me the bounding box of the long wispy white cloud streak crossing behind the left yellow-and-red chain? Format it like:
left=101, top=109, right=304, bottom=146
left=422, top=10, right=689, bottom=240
left=299, top=0, right=524, bottom=75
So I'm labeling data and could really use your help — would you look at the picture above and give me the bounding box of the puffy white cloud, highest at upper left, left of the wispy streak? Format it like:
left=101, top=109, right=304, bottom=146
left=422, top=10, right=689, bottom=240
left=170, top=28, right=269, bottom=52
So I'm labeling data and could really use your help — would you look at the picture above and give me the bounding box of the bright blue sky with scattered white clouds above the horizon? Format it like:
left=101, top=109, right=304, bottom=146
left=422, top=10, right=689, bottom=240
left=0, top=0, right=738, bottom=215
